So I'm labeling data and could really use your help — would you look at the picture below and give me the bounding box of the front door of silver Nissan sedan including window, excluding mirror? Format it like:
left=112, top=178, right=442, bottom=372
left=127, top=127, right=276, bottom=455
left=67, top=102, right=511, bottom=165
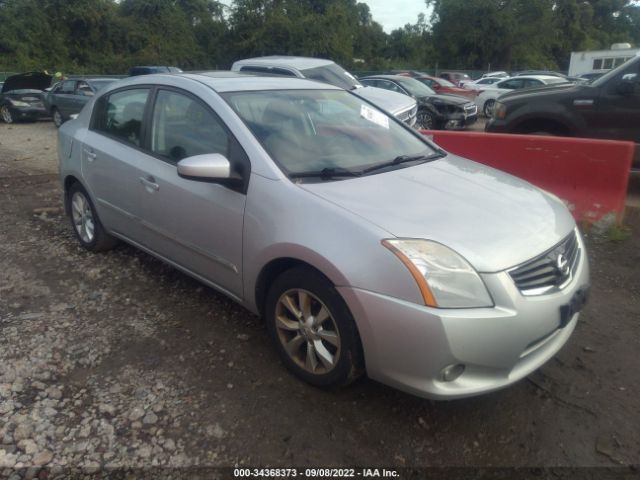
left=138, top=88, right=248, bottom=298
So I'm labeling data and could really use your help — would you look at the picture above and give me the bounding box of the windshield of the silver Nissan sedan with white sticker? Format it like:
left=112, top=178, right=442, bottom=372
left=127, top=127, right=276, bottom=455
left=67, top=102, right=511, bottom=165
left=222, top=90, right=437, bottom=180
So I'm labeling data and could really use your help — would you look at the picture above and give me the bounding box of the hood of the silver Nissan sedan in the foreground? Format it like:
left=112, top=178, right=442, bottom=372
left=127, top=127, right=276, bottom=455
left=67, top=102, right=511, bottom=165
left=300, top=155, right=575, bottom=273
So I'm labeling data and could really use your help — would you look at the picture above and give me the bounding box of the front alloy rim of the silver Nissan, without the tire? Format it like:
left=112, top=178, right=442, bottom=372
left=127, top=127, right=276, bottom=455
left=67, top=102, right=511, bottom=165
left=275, top=289, right=340, bottom=375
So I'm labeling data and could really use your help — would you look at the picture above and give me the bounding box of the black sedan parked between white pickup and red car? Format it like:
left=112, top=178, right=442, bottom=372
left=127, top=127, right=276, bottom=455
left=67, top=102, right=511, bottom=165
left=362, top=75, right=478, bottom=130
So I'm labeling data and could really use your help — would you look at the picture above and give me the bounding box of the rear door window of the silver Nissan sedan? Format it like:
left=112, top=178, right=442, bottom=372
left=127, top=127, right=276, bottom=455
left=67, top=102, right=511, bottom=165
left=95, top=88, right=149, bottom=147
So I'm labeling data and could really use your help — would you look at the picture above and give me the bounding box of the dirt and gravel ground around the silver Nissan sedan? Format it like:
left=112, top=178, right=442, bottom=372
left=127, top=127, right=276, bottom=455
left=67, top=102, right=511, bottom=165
left=0, top=122, right=640, bottom=479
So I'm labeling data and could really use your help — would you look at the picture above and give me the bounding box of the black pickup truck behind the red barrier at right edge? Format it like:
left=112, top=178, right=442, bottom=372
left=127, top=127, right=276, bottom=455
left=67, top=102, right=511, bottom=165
left=485, top=56, right=640, bottom=168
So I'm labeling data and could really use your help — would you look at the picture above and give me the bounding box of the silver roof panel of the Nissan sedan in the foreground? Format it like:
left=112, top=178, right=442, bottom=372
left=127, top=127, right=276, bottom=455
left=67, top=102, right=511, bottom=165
left=117, top=72, right=342, bottom=93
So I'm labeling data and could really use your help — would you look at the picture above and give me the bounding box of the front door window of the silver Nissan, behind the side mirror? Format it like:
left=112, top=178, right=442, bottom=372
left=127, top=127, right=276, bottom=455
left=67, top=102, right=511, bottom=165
left=151, top=90, right=229, bottom=163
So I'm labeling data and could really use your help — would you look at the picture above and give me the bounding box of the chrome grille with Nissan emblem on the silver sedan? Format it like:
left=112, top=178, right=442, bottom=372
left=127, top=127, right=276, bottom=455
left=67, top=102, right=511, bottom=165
left=509, top=231, right=580, bottom=295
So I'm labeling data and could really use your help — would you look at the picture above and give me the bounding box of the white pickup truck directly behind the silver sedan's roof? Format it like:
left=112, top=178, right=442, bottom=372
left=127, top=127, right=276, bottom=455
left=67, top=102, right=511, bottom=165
left=231, top=56, right=418, bottom=126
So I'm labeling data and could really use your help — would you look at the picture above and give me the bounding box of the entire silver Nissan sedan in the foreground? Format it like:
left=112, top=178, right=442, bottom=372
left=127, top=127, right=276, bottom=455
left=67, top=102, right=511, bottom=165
left=58, top=74, right=589, bottom=399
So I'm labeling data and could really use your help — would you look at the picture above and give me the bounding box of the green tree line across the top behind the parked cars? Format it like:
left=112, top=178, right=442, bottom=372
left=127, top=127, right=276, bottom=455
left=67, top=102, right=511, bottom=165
left=0, top=0, right=640, bottom=74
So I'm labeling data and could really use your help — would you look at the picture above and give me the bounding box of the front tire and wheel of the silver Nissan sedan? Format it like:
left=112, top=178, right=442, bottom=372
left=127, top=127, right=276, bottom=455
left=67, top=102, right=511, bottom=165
left=265, top=267, right=364, bottom=388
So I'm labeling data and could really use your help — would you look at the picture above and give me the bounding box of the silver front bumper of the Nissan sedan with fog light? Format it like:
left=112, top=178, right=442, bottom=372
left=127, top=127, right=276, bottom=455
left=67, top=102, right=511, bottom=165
left=339, top=232, right=589, bottom=399
